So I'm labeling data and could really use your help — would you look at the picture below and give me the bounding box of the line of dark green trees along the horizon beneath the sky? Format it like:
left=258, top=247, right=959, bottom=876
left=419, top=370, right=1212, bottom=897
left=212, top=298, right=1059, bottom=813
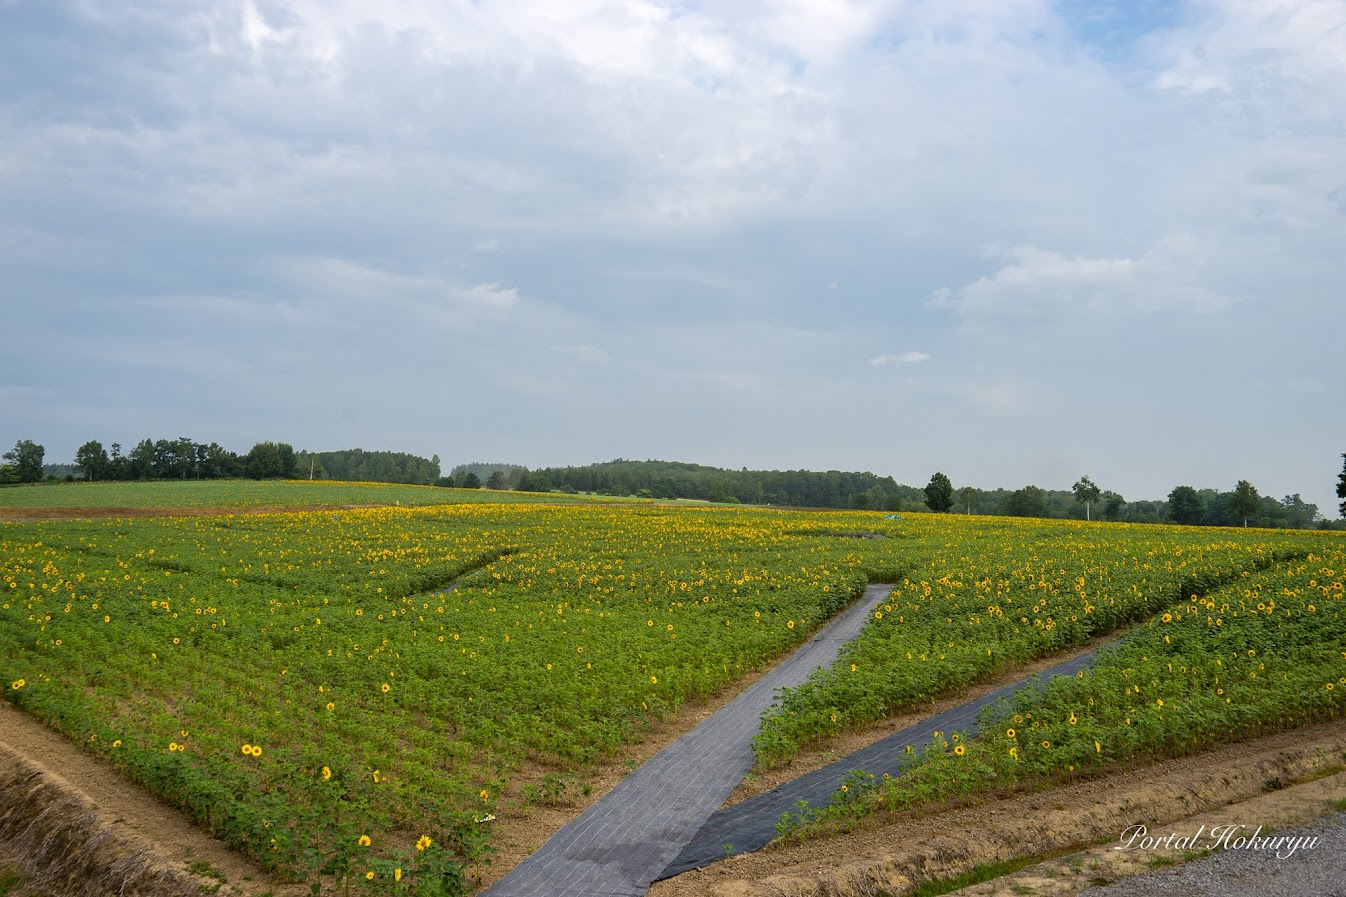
left=10, top=436, right=1346, bottom=529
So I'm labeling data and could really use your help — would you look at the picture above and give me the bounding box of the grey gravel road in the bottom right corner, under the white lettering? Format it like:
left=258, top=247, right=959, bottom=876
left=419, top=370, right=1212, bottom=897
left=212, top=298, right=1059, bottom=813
left=1082, top=812, right=1346, bottom=897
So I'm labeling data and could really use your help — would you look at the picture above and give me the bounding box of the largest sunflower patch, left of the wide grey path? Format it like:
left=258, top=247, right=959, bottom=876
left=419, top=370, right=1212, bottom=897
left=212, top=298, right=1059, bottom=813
left=0, top=498, right=910, bottom=893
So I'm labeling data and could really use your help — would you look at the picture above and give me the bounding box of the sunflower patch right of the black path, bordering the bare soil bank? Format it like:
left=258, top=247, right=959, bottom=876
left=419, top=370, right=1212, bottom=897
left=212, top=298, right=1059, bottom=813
left=791, top=540, right=1346, bottom=823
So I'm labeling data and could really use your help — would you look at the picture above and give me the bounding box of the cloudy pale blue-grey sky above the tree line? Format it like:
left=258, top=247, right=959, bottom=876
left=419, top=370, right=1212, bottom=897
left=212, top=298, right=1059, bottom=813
left=0, top=0, right=1346, bottom=517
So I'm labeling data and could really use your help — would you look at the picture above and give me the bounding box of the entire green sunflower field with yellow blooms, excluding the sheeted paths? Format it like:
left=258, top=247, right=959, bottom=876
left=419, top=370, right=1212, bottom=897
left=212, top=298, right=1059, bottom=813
left=0, top=484, right=1346, bottom=893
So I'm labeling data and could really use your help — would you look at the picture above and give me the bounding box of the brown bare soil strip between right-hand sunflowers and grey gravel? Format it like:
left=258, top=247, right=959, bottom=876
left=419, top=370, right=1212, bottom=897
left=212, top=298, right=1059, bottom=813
left=650, top=721, right=1346, bottom=897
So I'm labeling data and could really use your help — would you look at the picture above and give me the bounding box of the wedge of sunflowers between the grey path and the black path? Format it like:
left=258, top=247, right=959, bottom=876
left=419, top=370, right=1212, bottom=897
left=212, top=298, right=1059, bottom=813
left=754, top=517, right=1320, bottom=765
